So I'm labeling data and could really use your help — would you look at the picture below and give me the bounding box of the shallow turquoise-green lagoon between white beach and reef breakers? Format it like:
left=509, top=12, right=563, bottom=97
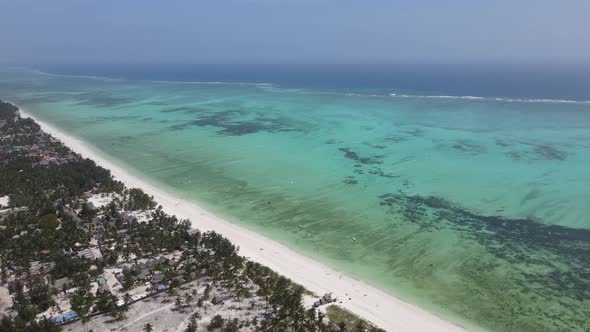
left=0, top=70, right=590, bottom=331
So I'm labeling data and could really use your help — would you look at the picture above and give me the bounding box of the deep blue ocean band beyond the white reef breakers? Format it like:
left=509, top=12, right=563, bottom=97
left=38, top=63, right=590, bottom=101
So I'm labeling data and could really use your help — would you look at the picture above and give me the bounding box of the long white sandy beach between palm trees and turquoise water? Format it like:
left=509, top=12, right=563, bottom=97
left=20, top=109, right=464, bottom=331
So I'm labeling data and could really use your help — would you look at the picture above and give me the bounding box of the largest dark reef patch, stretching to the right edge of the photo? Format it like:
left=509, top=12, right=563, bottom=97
left=379, top=192, right=590, bottom=304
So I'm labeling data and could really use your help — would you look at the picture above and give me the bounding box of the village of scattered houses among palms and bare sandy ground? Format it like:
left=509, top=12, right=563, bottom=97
left=2, top=185, right=342, bottom=331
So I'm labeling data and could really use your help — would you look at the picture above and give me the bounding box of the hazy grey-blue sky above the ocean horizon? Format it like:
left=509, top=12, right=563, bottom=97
left=0, top=0, right=590, bottom=64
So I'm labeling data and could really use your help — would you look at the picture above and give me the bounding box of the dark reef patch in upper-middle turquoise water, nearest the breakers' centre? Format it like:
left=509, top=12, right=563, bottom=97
left=170, top=110, right=302, bottom=136
